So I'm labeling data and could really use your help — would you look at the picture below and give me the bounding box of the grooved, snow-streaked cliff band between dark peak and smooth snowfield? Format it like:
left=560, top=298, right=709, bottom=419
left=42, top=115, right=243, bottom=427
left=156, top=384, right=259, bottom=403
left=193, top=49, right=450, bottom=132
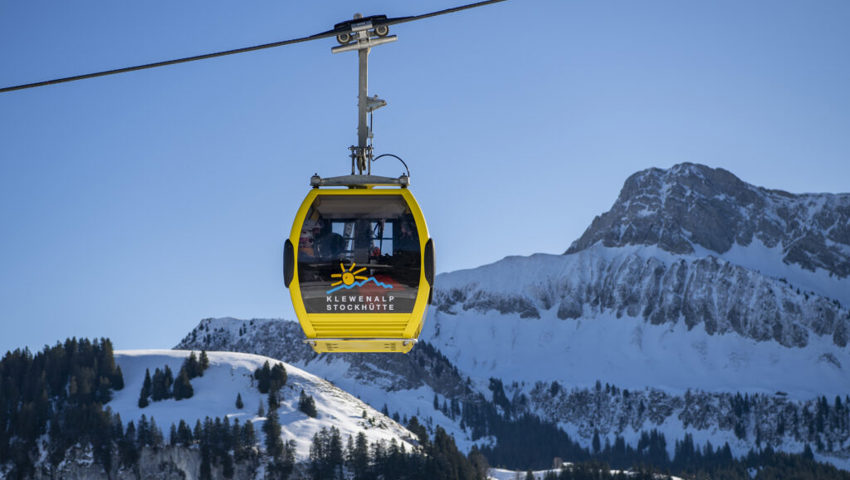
left=435, top=248, right=850, bottom=347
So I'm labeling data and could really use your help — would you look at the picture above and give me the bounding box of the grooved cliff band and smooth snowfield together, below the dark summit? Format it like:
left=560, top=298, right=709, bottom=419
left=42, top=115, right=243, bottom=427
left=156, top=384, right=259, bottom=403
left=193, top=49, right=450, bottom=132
left=430, top=246, right=850, bottom=399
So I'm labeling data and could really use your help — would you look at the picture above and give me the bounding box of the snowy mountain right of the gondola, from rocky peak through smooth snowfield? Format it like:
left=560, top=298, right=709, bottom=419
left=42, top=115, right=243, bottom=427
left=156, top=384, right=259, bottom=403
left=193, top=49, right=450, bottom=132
left=430, top=164, right=850, bottom=398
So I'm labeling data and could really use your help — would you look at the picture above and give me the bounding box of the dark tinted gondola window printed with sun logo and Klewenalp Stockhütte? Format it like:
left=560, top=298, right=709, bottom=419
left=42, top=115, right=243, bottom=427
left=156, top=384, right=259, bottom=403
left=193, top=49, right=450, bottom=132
left=298, top=195, right=421, bottom=313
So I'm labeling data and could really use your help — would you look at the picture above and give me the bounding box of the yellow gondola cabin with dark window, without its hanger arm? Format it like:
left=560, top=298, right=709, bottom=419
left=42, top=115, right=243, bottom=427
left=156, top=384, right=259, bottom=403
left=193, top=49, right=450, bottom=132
left=284, top=180, right=434, bottom=353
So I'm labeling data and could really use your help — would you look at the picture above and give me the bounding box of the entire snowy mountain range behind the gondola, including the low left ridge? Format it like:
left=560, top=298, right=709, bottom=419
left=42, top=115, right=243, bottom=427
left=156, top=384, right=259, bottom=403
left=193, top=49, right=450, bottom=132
left=178, top=164, right=850, bottom=468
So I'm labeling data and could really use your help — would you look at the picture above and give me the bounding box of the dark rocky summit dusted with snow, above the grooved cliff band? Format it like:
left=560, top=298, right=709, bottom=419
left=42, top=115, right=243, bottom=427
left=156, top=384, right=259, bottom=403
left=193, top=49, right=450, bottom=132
left=566, top=163, right=850, bottom=278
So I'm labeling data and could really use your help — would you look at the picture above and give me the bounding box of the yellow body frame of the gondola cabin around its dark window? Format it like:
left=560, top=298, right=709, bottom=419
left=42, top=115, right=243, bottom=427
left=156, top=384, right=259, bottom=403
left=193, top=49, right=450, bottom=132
left=289, top=187, right=431, bottom=353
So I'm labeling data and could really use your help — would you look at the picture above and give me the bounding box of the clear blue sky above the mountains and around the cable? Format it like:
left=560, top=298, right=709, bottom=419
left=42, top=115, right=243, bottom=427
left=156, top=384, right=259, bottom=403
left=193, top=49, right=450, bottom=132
left=0, top=0, right=850, bottom=351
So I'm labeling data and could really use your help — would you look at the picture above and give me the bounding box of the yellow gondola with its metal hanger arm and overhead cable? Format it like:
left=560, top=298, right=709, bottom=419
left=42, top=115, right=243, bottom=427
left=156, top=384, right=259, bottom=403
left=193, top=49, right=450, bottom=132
left=0, top=0, right=505, bottom=353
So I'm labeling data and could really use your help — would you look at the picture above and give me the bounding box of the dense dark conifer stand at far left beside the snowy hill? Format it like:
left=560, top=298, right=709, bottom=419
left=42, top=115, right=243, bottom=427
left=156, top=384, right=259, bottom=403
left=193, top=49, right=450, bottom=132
left=0, top=338, right=124, bottom=478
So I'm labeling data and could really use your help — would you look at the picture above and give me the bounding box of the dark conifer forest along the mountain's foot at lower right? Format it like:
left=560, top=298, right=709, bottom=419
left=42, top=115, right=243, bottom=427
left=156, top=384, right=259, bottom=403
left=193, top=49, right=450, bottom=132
left=454, top=379, right=850, bottom=480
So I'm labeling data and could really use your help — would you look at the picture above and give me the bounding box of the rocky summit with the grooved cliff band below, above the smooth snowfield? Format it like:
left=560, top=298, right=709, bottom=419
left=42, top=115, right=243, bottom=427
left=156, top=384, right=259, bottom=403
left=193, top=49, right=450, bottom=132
left=435, top=164, right=850, bottom=347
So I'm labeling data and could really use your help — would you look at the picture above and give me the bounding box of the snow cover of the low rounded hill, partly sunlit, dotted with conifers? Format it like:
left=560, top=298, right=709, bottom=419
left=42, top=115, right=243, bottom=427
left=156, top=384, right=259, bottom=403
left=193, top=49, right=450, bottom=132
left=107, top=350, right=415, bottom=460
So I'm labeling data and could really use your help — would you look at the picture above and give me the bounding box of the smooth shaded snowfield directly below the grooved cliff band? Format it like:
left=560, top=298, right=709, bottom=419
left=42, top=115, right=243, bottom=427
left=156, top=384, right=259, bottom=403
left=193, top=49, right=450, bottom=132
left=423, top=312, right=850, bottom=399
